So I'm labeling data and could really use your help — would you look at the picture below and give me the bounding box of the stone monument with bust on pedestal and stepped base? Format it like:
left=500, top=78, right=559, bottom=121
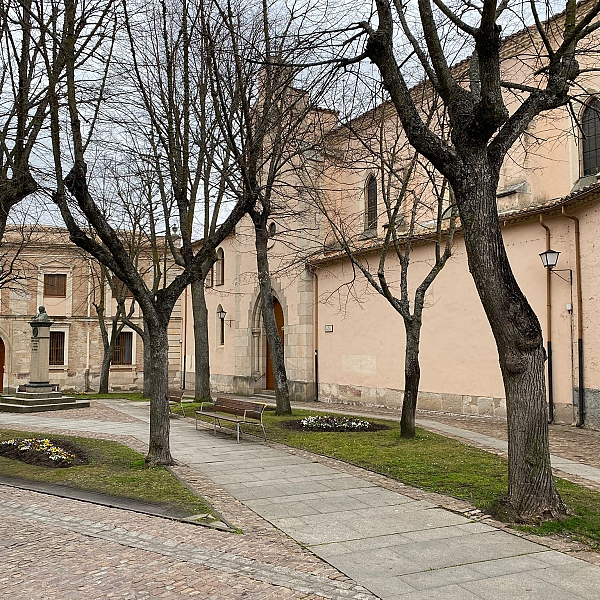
left=0, top=306, right=90, bottom=413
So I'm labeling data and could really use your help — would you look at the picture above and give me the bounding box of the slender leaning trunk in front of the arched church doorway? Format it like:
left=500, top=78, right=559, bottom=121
left=254, top=223, right=292, bottom=415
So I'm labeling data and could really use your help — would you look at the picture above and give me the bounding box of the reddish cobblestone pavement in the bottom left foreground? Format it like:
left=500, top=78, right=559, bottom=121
left=0, top=476, right=374, bottom=600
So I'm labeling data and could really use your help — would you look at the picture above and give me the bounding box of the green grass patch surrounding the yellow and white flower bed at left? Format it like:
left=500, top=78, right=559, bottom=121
left=0, top=429, right=212, bottom=515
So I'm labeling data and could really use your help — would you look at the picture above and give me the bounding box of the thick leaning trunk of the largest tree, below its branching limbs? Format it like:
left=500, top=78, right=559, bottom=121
left=452, top=155, right=567, bottom=521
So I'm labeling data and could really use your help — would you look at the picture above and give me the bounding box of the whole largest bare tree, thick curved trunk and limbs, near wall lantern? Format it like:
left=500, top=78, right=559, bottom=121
left=332, top=0, right=600, bottom=520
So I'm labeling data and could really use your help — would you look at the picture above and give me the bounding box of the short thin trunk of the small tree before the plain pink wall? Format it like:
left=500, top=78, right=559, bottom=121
left=400, top=317, right=421, bottom=439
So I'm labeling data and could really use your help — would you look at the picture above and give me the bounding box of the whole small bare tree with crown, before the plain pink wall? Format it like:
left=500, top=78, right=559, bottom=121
left=314, top=98, right=456, bottom=438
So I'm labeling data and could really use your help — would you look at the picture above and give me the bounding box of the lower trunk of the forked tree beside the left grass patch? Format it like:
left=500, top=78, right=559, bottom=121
left=144, top=319, right=175, bottom=466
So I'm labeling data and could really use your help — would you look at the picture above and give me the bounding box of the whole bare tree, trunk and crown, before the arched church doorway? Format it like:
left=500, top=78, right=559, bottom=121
left=204, top=0, right=332, bottom=414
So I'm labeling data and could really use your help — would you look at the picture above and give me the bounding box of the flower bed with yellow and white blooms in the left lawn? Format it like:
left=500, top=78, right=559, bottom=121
left=0, top=438, right=88, bottom=467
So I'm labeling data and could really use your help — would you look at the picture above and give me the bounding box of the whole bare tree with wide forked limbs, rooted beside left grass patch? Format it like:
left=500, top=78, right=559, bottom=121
left=45, top=0, right=245, bottom=464
